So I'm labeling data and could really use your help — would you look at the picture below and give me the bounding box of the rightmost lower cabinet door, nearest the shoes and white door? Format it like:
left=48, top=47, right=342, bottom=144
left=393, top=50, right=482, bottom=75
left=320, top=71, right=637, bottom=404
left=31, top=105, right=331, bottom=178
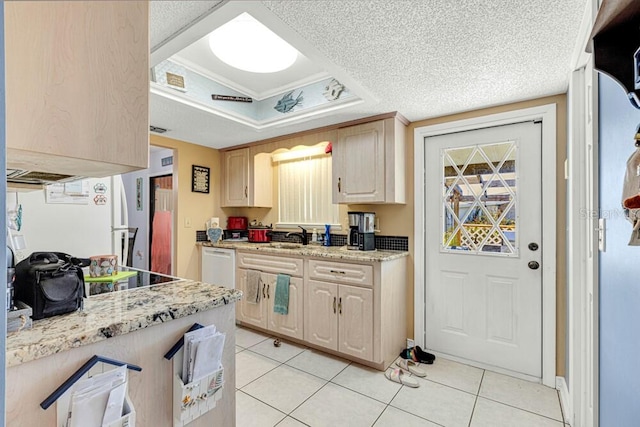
left=338, top=285, right=373, bottom=360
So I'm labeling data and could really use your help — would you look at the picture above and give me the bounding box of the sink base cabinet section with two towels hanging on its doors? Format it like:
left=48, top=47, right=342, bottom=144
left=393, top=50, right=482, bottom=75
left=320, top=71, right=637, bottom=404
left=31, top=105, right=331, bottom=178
left=236, top=253, right=304, bottom=339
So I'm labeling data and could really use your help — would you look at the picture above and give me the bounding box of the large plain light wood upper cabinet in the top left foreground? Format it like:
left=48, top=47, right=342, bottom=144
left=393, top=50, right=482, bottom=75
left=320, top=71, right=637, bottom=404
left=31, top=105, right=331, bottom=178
left=4, top=1, right=149, bottom=177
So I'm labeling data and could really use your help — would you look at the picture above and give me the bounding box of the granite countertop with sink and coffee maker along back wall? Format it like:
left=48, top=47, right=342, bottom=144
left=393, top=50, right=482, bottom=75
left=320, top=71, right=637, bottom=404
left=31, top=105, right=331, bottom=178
left=201, top=241, right=409, bottom=262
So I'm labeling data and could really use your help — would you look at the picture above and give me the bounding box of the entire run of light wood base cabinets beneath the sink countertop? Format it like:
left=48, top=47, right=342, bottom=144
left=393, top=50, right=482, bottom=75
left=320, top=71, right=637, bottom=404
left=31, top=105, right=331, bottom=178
left=236, top=250, right=407, bottom=369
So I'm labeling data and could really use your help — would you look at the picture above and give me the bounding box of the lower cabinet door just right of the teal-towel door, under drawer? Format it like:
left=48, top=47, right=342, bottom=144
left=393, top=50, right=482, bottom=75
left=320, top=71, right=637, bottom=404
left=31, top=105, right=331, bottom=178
left=304, top=280, right=338, bottom=350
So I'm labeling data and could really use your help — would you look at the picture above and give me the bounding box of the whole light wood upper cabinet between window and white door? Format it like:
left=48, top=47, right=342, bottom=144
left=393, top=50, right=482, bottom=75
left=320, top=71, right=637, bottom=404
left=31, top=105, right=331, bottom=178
left=332, top=117, right=405, bottom=204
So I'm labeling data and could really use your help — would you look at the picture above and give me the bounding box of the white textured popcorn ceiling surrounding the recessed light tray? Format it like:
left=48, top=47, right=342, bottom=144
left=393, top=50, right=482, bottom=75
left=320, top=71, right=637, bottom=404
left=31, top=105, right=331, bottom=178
left=151, top=0, right=588, bottom=148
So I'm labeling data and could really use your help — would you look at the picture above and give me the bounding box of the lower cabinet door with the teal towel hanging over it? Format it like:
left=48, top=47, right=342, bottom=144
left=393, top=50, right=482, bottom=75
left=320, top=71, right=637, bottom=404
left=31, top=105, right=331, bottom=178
left=262, top=273, right=304, bottom=339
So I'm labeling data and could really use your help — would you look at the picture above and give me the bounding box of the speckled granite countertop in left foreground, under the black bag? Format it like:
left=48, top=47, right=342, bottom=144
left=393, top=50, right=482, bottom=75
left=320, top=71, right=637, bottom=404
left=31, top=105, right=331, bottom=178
left=6, top=279, right=242, bottom=367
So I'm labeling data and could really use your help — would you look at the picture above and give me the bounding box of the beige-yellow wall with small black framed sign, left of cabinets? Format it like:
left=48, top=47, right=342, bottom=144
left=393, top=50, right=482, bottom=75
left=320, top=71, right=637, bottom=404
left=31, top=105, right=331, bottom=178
left=150, top=135, right=223, bottom=280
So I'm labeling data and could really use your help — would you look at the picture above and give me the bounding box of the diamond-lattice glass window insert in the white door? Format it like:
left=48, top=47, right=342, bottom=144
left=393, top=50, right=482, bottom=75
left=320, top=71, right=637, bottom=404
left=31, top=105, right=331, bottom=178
left=441, top=141, right=518, bottom=256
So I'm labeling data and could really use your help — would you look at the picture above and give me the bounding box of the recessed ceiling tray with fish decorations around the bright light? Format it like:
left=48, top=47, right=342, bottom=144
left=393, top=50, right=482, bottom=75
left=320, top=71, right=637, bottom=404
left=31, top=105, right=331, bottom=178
left=151, top=2, right=372, bottom=130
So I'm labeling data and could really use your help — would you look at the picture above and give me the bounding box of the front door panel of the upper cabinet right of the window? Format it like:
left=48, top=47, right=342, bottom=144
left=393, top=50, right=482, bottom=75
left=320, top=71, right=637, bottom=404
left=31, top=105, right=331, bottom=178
left=332, top=121, right=385, bottom=203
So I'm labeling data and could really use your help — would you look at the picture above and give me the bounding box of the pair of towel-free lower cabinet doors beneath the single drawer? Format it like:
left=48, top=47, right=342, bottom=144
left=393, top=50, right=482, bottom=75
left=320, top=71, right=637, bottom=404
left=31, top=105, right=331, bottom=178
left=305, top=280, right=373, bottom=360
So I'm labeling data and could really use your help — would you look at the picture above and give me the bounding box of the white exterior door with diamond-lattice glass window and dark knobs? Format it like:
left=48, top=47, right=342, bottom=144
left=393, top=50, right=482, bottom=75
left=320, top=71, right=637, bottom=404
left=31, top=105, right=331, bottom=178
left=424, top=122, right=544, bottom=378
